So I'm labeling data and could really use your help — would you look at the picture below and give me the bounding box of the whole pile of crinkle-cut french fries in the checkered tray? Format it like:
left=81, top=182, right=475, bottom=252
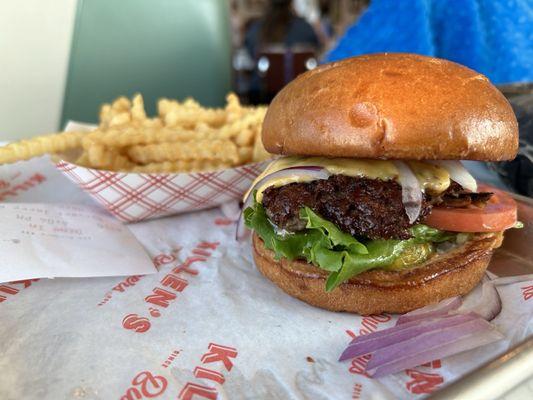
left=0, top=93, right=271, bottom=173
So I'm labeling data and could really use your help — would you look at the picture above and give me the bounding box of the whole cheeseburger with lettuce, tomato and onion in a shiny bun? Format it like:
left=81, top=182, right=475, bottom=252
left=243, top=53, right=518, bottom=314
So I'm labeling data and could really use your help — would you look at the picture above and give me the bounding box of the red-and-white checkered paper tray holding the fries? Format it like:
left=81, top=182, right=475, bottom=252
left=56, top=160, right=268, bottom=222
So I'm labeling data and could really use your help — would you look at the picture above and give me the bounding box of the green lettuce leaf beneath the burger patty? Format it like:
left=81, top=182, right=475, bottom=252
left=244, top=202, right=455, bottom=291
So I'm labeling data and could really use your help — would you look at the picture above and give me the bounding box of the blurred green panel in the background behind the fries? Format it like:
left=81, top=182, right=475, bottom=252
left=60, top=0, right=231, bottom=128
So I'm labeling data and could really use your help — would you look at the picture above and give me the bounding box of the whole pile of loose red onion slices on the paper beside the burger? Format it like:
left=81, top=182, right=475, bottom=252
left=339, top=276, right=504, bottom=377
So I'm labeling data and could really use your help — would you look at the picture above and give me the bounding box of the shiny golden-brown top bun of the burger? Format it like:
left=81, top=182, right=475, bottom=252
left=262, top=53, right=518, bottom=161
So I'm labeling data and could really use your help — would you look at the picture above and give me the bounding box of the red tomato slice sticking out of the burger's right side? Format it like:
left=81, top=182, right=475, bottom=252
left=423, top=185, right=516, bottom=232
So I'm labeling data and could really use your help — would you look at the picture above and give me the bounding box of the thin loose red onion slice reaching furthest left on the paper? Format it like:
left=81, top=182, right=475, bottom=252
left=339, top=313, right=472, bottom=361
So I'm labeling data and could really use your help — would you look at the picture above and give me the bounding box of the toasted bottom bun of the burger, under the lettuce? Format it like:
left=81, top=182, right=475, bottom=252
left=253, top=233, right=503, bottom=315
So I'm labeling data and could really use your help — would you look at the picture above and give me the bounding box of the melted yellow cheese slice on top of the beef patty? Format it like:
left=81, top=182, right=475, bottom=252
left=245, top=157, right=450, bottom=202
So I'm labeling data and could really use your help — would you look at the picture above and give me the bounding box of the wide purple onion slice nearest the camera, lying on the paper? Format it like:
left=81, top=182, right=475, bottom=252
left=367, top=315, right=504, bottom=378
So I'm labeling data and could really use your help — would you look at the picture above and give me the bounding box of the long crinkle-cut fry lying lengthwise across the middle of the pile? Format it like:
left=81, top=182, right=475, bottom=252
left=83, top=124, right=219, bottom=149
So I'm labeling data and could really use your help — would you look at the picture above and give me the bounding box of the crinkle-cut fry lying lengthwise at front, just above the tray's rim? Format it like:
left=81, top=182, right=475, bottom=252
left=127, top=139, right=239, bottom=164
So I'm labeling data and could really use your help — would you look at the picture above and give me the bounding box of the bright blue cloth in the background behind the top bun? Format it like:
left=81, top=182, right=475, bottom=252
left=326, top=0, right=533, bottom=83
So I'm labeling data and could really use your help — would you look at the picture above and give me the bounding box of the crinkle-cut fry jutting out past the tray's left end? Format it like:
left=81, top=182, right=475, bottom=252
left=0, top=132, right=85, bottom=164
